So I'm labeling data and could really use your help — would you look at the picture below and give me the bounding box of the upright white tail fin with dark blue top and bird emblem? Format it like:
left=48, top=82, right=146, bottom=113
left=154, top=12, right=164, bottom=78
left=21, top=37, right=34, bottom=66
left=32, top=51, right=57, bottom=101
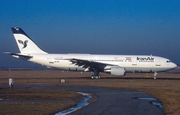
left=11, top=27, right=47, bottom=54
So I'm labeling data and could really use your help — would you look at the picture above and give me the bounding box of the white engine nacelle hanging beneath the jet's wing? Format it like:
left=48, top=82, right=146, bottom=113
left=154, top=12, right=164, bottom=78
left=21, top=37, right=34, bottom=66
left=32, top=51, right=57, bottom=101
left=111, top=66, right=126, bottom=76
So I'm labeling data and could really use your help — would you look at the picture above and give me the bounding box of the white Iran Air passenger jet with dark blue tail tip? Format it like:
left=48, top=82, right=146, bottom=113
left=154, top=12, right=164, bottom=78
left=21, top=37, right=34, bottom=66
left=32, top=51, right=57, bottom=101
left=4, top=27, right=177, bottom=79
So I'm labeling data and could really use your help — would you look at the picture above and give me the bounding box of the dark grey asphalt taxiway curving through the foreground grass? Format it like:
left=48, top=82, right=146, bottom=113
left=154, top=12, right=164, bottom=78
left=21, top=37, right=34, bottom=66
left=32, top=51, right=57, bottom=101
left=19, top=85, right=165, bottom=115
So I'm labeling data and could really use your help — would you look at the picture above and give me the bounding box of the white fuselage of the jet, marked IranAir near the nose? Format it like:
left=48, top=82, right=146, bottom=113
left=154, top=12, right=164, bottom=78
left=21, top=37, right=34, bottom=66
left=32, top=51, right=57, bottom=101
left=29, top=54, right=176, bottom=72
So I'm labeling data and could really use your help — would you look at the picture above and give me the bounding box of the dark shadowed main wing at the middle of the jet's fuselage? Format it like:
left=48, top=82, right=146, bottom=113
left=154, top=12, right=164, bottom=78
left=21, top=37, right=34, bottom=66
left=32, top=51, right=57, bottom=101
left=69, top=58, right=114, bottom=70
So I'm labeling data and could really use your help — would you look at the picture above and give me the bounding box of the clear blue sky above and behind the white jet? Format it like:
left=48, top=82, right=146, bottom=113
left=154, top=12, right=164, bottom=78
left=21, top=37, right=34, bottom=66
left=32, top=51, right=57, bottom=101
left=0, top=0, right=180, bottom=68
